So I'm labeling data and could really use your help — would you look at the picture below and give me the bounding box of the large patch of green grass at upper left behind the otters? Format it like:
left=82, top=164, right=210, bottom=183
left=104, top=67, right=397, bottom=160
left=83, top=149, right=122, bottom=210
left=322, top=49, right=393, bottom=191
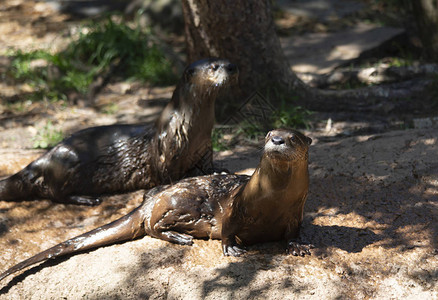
left=10, top=18, right=177, bottom=100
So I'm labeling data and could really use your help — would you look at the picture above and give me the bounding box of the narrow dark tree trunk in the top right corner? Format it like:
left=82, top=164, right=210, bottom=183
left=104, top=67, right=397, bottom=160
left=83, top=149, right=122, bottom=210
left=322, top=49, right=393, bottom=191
left=412, top=0, right=438, bottom=62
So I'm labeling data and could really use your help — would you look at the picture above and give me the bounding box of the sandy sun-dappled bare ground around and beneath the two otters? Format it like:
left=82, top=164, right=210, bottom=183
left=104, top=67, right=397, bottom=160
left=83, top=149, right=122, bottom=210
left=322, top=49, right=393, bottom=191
left=0, top=0, right=438, bottom=299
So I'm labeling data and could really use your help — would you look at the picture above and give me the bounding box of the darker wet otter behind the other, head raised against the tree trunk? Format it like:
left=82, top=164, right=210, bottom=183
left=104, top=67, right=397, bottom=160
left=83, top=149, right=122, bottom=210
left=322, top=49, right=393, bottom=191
left=0, top=58, right=238, bottom=205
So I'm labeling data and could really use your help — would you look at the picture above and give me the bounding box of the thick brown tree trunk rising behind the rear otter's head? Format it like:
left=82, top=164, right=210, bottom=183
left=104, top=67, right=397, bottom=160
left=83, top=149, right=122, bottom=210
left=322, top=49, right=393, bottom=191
left=182, top=0, right=304, bottom=96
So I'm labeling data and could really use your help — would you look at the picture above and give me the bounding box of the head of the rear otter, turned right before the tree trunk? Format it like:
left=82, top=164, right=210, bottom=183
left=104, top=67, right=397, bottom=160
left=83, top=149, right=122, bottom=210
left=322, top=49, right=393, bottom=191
left=184, top=58, right=239, bottom=91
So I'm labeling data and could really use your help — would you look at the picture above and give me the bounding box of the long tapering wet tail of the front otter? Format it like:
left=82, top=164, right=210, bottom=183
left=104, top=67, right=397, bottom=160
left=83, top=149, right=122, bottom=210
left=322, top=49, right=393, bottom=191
left=0, top=206, right=145, bottom=280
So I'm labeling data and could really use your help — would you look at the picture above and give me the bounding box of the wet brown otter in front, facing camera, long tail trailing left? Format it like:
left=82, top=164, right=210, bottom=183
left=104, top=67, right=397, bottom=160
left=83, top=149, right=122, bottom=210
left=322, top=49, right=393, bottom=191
left=0, top=129, right=312, bottom=280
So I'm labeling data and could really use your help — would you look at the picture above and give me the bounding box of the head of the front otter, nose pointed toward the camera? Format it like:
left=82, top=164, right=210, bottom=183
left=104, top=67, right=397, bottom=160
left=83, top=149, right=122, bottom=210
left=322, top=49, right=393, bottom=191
left=264, top=129, right=312, bottom=169
